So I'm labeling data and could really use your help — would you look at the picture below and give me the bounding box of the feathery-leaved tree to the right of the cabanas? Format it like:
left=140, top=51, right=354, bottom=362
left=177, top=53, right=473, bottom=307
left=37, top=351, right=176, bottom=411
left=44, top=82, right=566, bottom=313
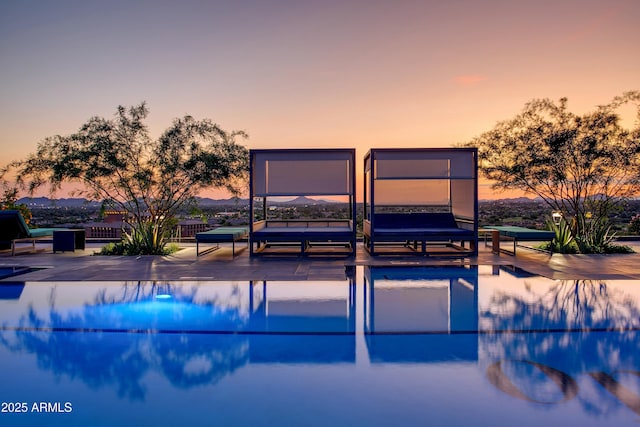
left=466, top=91, right=640, bottom=249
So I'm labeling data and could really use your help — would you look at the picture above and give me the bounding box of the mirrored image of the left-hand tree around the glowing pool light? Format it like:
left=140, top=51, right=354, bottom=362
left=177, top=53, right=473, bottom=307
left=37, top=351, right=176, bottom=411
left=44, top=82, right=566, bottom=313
left=0, top=283, right=248, bottom=399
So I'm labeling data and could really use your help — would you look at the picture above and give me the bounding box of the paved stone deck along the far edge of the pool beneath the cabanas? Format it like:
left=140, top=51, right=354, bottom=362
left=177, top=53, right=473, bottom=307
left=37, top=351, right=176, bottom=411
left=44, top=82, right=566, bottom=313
left=0, top=242, right=640, bottom=281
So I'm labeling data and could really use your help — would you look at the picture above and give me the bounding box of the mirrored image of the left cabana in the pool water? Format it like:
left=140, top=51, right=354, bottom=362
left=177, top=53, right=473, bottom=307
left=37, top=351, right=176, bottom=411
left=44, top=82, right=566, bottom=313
left=249, top=279, right=356, bottom=363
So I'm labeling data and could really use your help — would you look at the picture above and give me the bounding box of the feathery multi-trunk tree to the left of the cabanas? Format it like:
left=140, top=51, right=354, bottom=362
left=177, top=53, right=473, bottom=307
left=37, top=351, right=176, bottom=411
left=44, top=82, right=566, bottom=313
left=9, top=103, right=248, bottom=253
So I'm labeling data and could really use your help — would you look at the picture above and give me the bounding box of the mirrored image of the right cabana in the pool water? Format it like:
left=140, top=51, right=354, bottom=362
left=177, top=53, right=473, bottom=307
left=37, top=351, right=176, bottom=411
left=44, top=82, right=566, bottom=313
left=364, top=266, right=478, bottom=362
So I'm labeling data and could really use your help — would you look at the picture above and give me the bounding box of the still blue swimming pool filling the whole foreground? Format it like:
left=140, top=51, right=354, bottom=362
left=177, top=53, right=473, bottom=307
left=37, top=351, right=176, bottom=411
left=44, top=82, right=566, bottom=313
left=0, top=266, right=640, bottom=426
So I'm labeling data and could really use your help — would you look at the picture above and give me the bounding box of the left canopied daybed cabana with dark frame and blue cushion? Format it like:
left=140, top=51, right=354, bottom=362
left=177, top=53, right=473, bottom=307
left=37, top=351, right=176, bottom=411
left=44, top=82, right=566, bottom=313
left=249, top=149, right=356, bottom=255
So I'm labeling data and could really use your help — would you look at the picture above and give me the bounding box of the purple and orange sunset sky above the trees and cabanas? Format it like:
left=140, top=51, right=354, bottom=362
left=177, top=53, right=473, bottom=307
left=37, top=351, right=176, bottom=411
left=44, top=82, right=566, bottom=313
left=0, top=0, right=640, bottom=201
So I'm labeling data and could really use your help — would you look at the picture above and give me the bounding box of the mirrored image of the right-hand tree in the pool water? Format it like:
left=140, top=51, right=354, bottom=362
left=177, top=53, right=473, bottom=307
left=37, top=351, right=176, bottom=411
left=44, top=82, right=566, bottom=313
left=479, top=280, right=640, bottom=413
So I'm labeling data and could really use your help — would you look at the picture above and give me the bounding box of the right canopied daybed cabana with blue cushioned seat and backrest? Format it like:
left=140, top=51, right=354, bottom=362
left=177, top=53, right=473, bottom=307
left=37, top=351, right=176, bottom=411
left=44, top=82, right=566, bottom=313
left=363, top=148, right=478, bottom=256
